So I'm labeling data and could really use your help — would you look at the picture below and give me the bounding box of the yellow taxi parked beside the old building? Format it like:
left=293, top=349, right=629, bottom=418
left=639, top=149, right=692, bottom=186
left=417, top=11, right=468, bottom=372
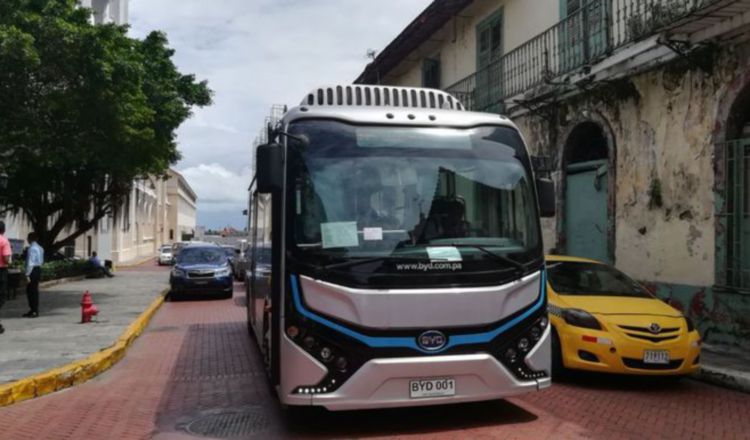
left=547, top=255, right=701, bottom=376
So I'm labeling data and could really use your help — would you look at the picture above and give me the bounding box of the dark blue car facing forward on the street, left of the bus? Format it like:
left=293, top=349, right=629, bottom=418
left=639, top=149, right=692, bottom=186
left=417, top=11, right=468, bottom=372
left=169, top=243, right=233, bottom=298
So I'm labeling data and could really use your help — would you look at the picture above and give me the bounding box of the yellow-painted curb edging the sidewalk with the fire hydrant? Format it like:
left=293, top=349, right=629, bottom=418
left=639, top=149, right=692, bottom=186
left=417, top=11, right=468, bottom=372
left=0, top=289, right=168, bottom=407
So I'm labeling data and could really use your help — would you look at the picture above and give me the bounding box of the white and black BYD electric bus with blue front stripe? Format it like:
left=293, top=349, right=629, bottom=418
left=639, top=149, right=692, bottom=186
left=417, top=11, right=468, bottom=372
left=247, top=85, right=554, bottom=410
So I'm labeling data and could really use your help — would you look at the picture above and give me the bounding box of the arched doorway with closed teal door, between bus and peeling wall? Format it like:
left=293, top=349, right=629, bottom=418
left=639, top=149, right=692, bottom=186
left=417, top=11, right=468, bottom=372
left=563, top=121, right=613, bottom=263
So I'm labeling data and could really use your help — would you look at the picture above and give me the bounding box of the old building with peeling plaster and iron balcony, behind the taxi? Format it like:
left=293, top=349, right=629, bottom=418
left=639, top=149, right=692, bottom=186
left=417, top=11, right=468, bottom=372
left=356, top=0, right=750, bottom=347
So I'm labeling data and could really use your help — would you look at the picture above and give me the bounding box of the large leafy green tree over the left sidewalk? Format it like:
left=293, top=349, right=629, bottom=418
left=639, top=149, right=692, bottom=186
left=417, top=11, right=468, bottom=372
left=0, top=0, right=211, bottom=252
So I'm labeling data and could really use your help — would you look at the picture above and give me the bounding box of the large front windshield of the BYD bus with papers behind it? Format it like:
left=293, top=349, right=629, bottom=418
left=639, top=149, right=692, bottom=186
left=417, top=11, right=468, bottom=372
left=288, top=120, right=541, bottom=280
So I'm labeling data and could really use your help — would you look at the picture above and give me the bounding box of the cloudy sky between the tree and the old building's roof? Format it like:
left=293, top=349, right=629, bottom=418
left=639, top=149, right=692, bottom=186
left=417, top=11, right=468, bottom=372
left=130, top=0, right=431, bottom=229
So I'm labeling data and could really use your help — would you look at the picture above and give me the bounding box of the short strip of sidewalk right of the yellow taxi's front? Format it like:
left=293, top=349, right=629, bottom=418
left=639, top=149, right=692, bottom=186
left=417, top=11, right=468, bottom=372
left=696, top=344, right=750, bottom=393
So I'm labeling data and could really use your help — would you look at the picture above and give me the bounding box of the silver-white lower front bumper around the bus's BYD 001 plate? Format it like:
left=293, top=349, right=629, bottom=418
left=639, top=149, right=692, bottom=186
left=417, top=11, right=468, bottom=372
left=281, top=327, right=551, bottom=411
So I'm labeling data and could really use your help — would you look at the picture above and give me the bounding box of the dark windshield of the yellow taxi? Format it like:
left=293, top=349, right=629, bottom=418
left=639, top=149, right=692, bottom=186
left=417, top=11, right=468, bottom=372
left=547, top=261, right=651, bottom=298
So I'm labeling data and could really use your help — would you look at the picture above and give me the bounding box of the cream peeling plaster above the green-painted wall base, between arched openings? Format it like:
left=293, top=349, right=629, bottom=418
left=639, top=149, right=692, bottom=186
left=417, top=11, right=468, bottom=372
left=516, top=45, right=750, bottom=285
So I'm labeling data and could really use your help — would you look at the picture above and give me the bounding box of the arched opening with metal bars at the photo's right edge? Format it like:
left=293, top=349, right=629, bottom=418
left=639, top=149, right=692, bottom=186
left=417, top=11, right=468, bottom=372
left=716, top=84, right=750, bottom=289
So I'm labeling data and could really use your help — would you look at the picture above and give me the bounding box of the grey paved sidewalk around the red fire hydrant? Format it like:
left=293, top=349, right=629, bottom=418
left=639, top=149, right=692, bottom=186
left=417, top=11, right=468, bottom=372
left=0, top=265, right=169, bottom=385
